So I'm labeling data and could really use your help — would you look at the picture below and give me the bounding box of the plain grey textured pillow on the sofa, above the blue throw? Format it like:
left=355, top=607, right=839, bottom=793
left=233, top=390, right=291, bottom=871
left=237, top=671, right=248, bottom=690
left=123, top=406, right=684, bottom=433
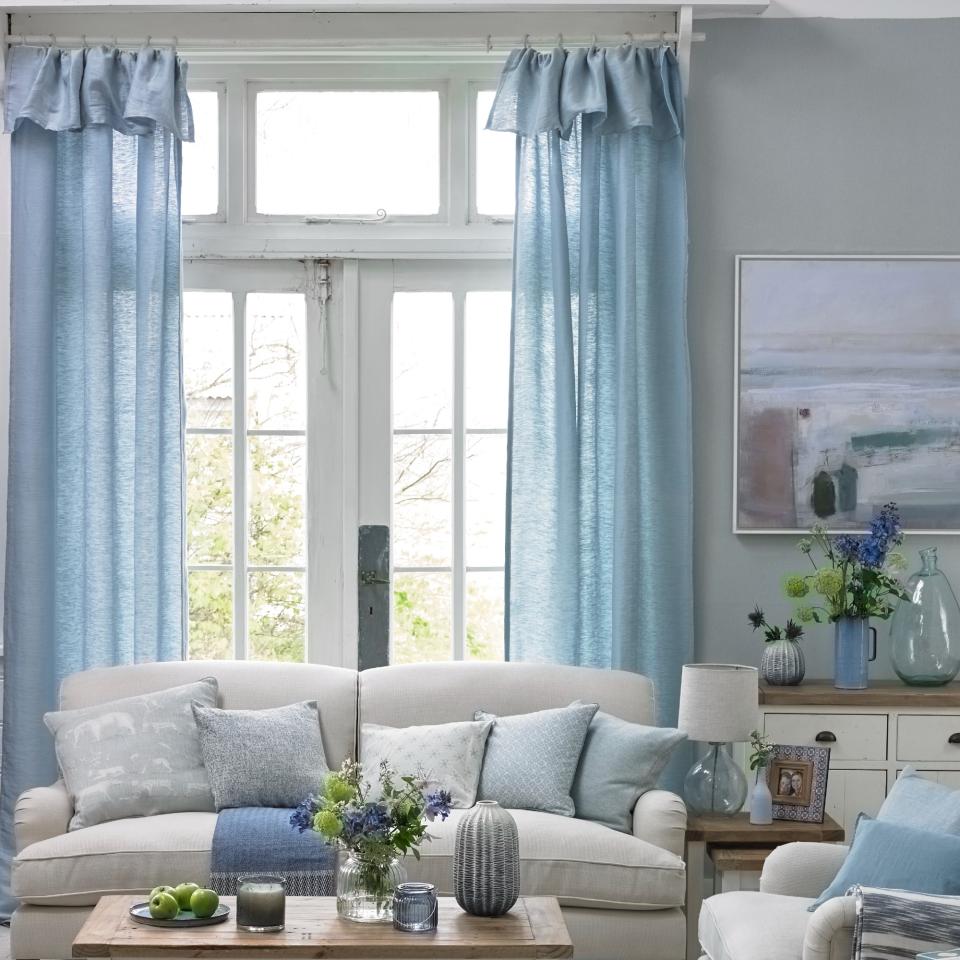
left=193, top=700, right=329, bottom=810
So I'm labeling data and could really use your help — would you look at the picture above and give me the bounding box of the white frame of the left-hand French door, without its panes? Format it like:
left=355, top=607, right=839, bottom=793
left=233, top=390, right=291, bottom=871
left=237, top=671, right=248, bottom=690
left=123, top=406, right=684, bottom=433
left=184, top=260, right=357, bottom=666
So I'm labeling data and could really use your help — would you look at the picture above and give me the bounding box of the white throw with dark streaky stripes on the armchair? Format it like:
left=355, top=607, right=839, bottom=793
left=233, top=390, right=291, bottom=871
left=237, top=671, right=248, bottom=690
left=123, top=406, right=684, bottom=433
left=850, top=887, right=960, bottom=960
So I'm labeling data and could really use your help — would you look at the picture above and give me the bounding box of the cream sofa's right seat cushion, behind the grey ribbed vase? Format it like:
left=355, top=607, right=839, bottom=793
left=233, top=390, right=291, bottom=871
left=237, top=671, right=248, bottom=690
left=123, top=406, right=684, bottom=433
left=405, top=810, right=685, bottom=910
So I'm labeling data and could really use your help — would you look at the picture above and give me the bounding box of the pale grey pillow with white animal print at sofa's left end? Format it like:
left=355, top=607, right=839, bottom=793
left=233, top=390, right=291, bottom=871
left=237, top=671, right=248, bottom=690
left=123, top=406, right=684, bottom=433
left=43, top=677, right=217, bottom=830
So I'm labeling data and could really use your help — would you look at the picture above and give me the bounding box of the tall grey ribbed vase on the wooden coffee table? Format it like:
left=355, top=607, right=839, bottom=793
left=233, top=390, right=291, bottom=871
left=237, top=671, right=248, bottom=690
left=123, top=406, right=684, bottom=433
left=453, top=800, right=520, bottom=917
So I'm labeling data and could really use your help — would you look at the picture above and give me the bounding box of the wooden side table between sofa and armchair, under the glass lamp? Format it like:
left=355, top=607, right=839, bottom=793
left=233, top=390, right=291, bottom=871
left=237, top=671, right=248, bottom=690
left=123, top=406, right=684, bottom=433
left=686, top=813, right=844, bottom=960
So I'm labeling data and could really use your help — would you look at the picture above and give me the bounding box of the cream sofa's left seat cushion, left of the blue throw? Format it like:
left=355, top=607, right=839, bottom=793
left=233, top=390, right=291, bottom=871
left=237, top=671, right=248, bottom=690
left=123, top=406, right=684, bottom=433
left=12, top=813, right=217, bottom=906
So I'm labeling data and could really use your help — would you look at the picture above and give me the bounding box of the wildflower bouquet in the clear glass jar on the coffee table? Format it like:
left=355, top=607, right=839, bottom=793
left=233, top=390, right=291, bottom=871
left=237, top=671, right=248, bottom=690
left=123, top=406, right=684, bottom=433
left=290, top=760, right=451, bottom=903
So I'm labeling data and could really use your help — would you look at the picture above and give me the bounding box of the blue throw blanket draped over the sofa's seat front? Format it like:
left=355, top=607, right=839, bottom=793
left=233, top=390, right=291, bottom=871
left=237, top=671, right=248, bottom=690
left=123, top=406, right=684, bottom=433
left=210, top=807, right=337, bottom=897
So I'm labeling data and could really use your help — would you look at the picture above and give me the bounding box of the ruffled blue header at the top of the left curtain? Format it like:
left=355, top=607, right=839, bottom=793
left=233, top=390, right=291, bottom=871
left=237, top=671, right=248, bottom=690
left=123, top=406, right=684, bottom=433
left=6, top=46, right=193, bottom=141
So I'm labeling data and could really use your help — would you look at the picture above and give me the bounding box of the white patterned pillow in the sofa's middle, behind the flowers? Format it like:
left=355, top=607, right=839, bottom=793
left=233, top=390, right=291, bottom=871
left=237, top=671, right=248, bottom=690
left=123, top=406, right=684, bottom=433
left=360, top=720, right=493, bottom=807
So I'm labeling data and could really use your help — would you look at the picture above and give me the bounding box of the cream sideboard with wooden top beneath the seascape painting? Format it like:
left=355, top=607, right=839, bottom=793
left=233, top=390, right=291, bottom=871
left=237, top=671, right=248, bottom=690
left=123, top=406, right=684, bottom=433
left=760, top=680, right=960, bottom=838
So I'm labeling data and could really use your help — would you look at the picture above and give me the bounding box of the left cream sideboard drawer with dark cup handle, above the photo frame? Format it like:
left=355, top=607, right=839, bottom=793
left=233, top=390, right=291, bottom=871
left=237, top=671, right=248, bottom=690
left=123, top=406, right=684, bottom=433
left=763, top=713, right=888, bottom=762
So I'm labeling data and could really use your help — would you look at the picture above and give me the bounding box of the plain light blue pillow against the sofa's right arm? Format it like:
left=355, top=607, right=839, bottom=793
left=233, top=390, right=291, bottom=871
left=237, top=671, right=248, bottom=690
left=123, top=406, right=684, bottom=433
left=571, top=711, right=687, bottom=833
